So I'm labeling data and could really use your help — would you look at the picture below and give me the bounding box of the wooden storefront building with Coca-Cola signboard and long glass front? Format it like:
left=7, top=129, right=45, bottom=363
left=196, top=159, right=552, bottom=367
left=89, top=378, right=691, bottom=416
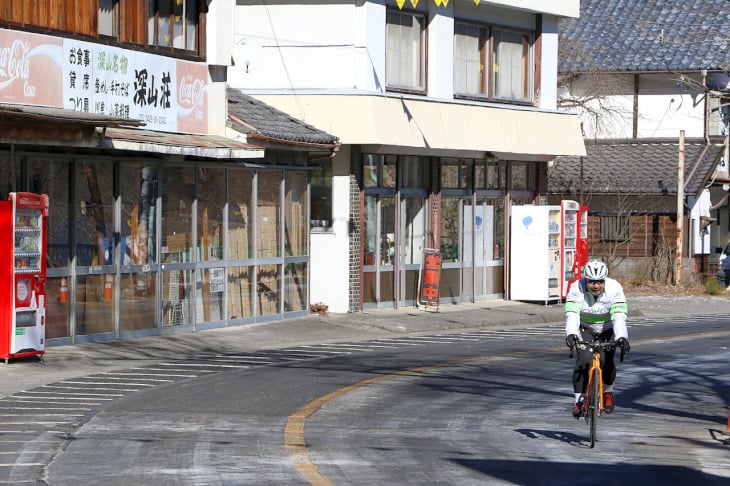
left=0, top=2, right=337, bottom=346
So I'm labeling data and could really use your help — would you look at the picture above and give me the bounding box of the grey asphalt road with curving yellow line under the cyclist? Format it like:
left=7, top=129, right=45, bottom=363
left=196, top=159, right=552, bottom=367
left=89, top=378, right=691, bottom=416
left=5, top=317, right=730, bottom=485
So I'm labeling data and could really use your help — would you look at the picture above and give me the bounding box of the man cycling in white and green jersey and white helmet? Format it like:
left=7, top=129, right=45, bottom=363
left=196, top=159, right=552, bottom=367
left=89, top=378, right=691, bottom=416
left=565, top=260, right=630, bottom=418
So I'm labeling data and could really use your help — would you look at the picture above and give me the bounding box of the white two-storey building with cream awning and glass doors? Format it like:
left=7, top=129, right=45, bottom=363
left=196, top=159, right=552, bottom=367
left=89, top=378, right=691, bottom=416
left=229, top=0, right=585, bottom=313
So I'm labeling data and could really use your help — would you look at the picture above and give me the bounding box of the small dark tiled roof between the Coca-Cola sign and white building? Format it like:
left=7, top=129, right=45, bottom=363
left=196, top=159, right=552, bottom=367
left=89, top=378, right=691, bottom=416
left=228, top=89, right=338, bottom=145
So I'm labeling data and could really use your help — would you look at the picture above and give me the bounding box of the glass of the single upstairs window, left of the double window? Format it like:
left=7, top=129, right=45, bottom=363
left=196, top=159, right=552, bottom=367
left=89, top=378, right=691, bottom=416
left=385, top=9, right=426, bottom=91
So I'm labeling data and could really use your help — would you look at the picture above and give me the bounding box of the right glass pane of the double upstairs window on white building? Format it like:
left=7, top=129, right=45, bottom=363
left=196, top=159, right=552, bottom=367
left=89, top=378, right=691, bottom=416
left=492, top=28, right=533, bottom=101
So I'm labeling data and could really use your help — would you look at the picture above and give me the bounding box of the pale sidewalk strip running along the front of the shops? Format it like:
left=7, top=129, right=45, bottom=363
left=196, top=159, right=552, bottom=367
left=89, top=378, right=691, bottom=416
left=0, top=295, right=730, bottom=398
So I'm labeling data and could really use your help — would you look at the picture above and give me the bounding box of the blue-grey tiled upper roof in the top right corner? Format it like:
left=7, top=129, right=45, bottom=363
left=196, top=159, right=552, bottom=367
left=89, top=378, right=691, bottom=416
left=558, top=0, right=730, bottom=73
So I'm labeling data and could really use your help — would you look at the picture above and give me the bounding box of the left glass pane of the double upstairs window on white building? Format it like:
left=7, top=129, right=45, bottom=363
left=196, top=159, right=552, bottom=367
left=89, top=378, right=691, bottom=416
left=454, top=22, right=488, bottom=95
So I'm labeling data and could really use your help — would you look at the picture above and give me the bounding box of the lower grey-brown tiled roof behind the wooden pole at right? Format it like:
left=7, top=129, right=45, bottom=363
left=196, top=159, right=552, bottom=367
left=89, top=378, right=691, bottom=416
left=548, top=139, right=723, bottom=195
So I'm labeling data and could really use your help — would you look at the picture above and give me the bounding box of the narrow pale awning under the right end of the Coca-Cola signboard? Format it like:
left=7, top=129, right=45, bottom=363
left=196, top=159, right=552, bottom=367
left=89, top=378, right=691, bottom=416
left=99, top=128, right=264, bottom=159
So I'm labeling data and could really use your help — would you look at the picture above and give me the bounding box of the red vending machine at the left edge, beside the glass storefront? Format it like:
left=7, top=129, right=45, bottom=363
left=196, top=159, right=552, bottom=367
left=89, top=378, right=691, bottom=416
left=0, top=192, right=48, bottom=364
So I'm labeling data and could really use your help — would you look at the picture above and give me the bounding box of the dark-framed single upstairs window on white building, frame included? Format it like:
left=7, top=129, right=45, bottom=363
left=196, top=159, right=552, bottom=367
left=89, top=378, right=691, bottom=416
left=385, top=8, right=428, bottom=94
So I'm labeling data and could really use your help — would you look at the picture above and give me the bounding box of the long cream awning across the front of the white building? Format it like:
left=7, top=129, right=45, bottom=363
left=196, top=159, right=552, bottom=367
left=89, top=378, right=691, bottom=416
left=252, top=93, right=586, bottom=160
